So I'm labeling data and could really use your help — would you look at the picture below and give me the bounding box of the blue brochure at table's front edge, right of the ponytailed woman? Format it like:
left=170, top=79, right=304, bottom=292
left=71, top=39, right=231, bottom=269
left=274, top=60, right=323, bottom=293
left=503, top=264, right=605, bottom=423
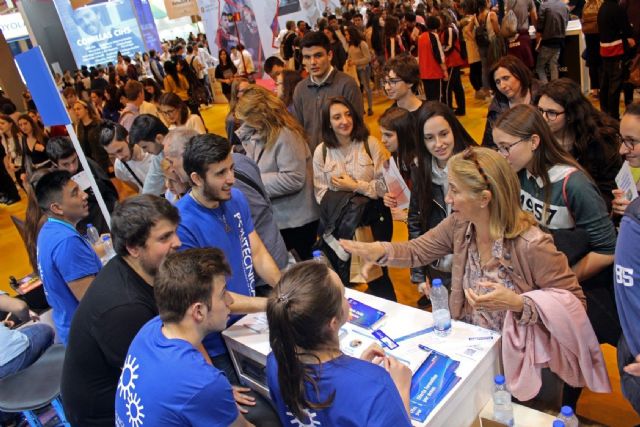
left=409, top=351, right=460, bottom=422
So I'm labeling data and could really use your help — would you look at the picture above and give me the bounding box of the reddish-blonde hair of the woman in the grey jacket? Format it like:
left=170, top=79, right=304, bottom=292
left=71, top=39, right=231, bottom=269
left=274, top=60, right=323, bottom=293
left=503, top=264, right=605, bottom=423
left=236, top=85, right=306, bottom=148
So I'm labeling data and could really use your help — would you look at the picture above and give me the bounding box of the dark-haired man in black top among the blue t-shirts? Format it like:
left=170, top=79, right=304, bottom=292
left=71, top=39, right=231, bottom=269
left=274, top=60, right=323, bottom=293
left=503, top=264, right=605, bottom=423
left=61, top=195, right=180, bottom=427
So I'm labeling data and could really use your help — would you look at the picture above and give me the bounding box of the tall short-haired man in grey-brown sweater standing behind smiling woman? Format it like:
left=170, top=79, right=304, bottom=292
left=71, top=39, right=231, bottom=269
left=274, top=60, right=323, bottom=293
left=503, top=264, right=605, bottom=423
left=293, top=31, right=364, bottom=152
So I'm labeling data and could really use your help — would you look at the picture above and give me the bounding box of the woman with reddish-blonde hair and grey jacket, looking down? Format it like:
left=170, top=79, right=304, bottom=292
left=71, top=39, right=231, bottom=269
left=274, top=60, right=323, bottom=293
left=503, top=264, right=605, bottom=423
left=235, top=85, right=319, bottom=259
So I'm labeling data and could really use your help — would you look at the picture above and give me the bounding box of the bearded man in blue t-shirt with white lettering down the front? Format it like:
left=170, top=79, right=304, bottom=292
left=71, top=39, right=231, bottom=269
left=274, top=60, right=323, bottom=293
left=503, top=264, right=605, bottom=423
left=176, top=134, right=280, bottom=425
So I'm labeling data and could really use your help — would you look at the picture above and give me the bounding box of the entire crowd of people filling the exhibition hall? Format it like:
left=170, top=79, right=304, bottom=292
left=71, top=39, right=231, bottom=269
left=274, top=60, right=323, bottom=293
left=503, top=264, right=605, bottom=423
left=0, top=0, right=640, bottom=426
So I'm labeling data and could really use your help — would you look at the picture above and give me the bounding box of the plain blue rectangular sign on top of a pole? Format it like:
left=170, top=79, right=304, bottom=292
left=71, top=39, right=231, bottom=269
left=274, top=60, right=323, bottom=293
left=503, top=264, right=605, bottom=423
left=15, top=46, right=71, bottom=126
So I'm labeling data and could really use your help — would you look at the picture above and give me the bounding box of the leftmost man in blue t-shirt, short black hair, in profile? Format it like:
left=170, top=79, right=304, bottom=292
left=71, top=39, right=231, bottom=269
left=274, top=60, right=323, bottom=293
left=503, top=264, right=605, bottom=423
left=35, top=170, right=102, bottom=345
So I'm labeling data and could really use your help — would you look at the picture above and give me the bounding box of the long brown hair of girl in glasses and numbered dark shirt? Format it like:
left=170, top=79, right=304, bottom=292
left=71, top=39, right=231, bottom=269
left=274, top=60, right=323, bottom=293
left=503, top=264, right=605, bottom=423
left=494, top=104, right=589, bottom=217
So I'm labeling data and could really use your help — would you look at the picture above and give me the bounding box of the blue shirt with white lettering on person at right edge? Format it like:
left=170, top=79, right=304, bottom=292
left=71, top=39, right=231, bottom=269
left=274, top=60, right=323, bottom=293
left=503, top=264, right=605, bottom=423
left=613, top=199, right=640, bottom=357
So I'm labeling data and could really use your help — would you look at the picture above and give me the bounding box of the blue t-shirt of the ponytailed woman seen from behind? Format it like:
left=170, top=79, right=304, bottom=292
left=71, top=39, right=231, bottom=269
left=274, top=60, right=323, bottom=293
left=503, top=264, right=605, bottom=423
left=267, top=353, right=411, bottom=427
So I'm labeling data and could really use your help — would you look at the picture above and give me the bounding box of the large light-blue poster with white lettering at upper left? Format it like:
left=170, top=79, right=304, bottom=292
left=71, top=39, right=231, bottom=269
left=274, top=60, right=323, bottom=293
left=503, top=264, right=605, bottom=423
left=54, top=0, right=145, bottom=68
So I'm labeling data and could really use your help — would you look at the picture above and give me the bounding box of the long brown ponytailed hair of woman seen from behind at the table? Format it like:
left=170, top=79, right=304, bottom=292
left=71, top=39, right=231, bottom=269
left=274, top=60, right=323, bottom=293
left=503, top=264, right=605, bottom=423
left=267, top=261, right=343, bottom=420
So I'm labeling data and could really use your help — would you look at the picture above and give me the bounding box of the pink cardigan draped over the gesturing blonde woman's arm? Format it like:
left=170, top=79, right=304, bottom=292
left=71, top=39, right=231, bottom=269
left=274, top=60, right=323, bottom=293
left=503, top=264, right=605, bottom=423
left=502, top=288, right=611, bottom=400
